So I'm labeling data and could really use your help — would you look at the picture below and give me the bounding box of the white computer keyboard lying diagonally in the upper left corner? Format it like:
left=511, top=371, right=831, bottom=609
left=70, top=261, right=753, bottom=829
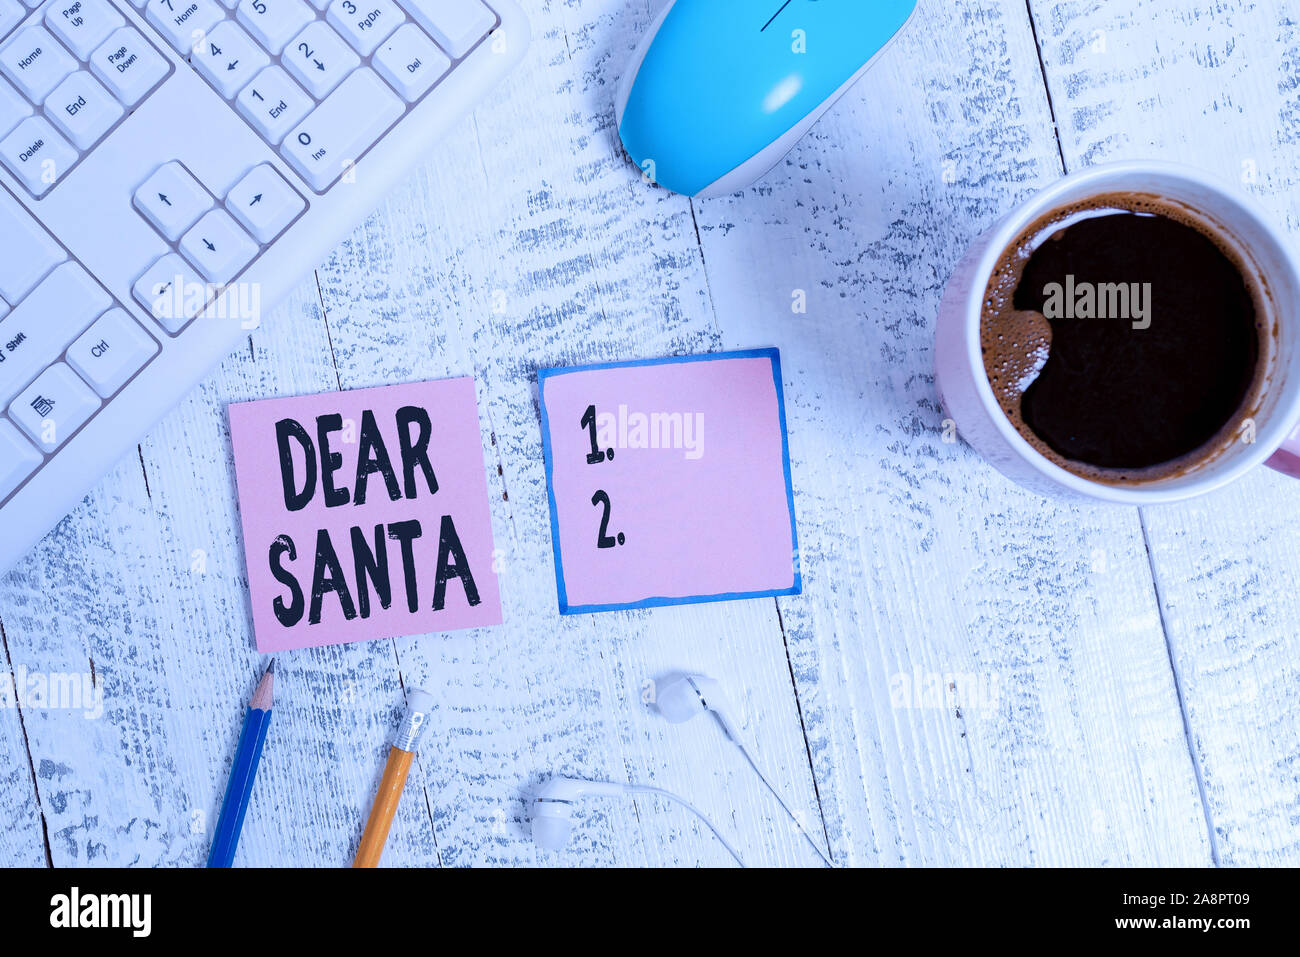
left=0, top=0, right=529, bottom=572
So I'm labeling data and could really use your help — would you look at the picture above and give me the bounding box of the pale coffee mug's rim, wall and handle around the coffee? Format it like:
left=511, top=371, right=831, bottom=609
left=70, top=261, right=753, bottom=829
left=935, top=163, right=1300, bottom=505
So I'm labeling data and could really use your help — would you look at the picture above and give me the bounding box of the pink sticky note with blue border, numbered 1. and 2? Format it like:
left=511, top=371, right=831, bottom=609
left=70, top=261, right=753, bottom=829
left=538, top=348, right=801, bottom=614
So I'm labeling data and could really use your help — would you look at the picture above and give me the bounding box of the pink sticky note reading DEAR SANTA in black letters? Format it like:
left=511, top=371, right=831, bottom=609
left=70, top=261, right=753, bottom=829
left=230, top=378, right=502, bottom=653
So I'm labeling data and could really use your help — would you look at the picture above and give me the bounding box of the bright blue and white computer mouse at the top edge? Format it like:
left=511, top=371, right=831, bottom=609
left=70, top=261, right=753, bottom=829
left=616, top=0, right=917, bottom=196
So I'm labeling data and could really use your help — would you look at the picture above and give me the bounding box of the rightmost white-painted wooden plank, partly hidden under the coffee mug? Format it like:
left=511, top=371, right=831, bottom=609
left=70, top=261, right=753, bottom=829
left=1032, top=0, right=1300, bottom=866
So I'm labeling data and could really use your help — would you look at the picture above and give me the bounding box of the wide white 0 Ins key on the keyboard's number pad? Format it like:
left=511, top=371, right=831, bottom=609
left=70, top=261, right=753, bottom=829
left=281, top=70, right=404, bottom=192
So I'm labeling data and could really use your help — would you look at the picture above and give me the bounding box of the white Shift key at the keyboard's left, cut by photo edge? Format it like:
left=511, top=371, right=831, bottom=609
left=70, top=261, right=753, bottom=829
left=0, top=263, right=113, bottom=404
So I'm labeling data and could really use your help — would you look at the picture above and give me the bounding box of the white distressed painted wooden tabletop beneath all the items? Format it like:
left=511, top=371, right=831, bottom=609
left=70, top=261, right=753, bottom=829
left=0, top=0, right=1300, bottom=865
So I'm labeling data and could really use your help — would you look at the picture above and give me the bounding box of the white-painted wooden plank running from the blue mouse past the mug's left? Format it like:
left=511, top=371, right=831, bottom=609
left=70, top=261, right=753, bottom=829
left=696, top=0, right=1210, bottom=865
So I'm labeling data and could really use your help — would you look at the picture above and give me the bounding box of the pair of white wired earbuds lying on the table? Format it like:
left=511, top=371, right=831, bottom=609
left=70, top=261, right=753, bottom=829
left=533, top=675, right=833, bottom=867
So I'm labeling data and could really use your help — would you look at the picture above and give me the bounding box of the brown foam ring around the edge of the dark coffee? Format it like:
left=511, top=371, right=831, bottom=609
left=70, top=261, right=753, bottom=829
left=980, top=192, right=1279, bottom=486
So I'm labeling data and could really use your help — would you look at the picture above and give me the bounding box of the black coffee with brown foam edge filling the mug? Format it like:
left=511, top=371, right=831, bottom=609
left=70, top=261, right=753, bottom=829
left=980, top=192, right=1271, bottom=484
